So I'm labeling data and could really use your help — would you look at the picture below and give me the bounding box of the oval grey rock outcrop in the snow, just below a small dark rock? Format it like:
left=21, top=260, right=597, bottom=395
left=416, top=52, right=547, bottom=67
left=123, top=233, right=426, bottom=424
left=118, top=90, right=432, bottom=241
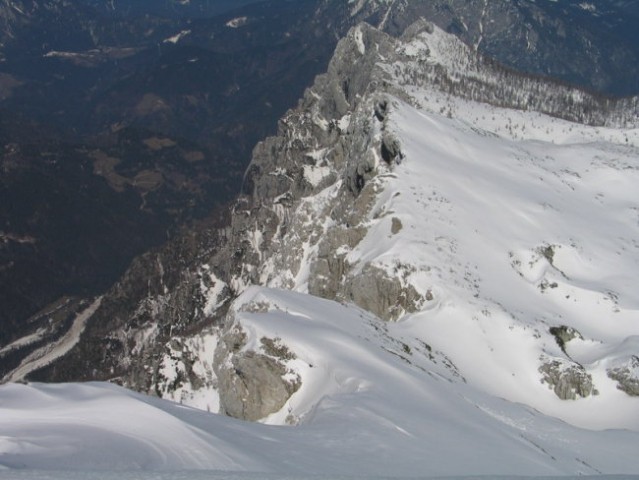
left=539, top=359, right=598, bottom=400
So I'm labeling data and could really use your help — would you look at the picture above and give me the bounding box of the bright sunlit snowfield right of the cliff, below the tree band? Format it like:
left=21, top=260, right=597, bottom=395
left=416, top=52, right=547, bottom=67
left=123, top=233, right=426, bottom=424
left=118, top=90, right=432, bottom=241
left=347, top=92, right=639, bottom=429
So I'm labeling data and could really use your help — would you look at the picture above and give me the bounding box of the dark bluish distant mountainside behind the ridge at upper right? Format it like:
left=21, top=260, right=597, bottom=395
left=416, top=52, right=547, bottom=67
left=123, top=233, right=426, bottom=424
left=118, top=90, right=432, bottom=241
left=336, top=0, right=639, bottom=95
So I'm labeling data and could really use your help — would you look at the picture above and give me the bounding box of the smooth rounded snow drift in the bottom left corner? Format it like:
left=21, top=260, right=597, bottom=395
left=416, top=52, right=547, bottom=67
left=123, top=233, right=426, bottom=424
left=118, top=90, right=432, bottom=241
left=0, top=384, right=258, bottom=470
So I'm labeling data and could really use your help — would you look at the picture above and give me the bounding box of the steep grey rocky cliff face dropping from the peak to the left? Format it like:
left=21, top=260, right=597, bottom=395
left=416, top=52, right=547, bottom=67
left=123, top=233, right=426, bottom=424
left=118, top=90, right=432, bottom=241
left=32, top=20, right=404, bottom=393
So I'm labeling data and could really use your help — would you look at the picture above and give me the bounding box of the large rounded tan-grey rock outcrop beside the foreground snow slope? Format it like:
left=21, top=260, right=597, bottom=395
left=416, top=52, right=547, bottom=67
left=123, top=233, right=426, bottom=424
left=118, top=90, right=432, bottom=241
left=213, top=325, right=301, bottom=421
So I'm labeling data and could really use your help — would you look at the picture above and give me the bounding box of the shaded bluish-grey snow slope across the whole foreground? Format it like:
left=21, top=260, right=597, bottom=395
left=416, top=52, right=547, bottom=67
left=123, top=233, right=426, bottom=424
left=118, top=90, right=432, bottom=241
left=0, top=288, right=639, bottom=478
